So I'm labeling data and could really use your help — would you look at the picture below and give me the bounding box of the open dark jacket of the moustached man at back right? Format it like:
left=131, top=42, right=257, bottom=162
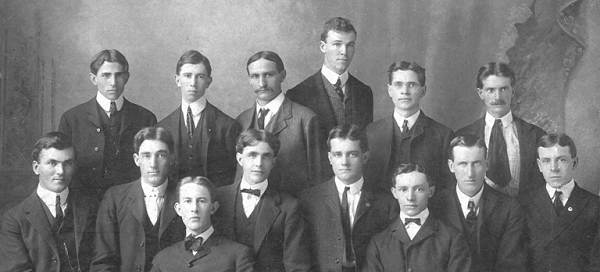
left=456, top=115, right=546, bottom=195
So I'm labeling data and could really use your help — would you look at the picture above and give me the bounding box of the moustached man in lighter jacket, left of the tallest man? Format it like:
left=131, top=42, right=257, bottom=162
left=237, top=51, right=321, bottom=196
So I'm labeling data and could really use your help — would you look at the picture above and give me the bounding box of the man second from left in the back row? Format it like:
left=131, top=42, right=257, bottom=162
left=158, top=50, right=241, bottom=186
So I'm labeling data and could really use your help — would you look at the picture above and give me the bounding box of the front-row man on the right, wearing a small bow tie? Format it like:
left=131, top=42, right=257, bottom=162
left=362, top=164, right=471, bottom=272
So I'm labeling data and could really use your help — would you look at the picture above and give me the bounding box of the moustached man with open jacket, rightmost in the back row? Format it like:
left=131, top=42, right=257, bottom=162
left=456, top=62, right=546, bottom=196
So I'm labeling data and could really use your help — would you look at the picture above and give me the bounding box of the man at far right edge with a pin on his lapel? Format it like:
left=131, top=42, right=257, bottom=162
left=521, top=133, right=600, bottom=272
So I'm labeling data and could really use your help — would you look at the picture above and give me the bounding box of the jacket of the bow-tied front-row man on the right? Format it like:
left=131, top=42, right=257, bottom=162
left=362, top=216, right=471, bottom=272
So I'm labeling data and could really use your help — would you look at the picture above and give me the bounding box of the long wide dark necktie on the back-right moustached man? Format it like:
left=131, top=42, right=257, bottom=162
left=487, top=119, right=511, bottom=187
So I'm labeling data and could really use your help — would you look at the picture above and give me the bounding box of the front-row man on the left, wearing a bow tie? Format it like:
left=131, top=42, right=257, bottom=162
left=151, top=177, right=254, bottom=272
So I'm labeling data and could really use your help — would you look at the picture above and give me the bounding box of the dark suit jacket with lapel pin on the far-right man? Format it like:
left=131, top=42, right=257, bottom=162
left=521, top=185, right=600, bottom=272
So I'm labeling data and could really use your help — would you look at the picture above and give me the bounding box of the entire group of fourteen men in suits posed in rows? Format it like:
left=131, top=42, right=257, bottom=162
left=0, top=17, right=600, bottom=272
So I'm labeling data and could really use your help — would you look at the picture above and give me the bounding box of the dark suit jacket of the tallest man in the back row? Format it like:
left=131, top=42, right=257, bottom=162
left=286, top=69, right=373, bottom=180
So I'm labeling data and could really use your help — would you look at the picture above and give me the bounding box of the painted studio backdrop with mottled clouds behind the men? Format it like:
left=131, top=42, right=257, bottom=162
left=0, top=0, right=600, bottom=212
